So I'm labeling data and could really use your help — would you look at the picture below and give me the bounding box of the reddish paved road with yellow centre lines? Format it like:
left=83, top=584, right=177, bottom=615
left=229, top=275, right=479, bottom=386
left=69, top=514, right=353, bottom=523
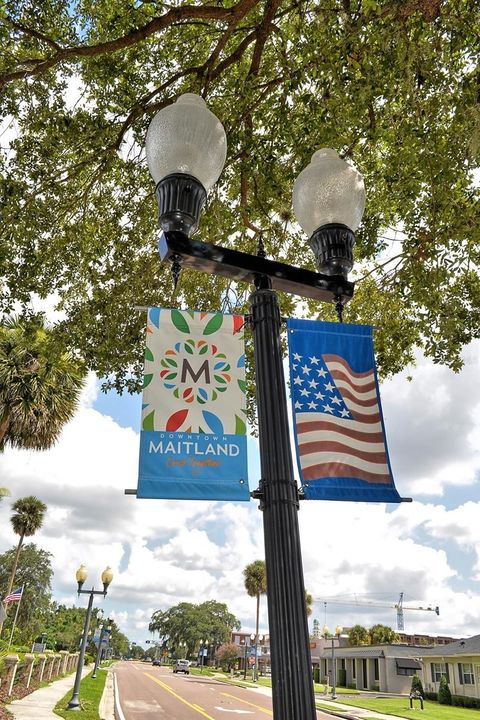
left=115, top=662, right=332, bottom=720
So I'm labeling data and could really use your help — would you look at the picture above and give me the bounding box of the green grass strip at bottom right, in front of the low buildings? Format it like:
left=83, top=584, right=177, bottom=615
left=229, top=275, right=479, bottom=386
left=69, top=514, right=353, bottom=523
left=317, top=697, right=480, bottom=720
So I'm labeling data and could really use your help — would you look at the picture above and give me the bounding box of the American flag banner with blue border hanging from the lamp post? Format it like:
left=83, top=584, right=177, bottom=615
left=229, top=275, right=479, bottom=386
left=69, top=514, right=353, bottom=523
left=287, top=320, right=402, bottom=503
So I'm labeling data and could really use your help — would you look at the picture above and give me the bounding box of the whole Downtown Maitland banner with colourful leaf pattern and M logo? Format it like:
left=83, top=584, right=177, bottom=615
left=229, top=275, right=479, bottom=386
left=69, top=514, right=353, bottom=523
left=137, top=308, right=250, bottom=501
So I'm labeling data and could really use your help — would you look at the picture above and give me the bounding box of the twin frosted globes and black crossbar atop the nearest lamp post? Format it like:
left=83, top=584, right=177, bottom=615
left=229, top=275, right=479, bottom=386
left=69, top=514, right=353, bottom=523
left=145, top=93, right=365, bottom=311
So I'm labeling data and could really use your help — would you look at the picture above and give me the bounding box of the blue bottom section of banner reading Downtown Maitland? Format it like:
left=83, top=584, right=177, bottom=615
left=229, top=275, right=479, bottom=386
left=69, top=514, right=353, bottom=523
left=137, top=430, right=250, bottom=502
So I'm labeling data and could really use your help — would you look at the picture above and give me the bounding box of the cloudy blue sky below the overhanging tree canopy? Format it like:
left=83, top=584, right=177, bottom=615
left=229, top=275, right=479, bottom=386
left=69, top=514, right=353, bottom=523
left=0, top=334, right=480, bottom=647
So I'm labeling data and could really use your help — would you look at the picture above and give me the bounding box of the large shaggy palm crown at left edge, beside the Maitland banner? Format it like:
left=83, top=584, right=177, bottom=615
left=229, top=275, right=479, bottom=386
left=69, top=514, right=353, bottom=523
left=0, top=315, right=85, bottom=452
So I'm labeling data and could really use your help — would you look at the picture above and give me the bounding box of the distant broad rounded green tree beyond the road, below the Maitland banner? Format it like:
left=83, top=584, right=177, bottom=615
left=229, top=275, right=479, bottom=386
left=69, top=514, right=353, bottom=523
left=148, top=600, right=241, bottom=657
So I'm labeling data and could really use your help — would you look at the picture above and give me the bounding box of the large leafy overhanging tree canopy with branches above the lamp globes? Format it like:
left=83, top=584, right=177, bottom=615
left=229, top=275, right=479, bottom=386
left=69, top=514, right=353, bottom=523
left=0, top=0, right=480, bottom=389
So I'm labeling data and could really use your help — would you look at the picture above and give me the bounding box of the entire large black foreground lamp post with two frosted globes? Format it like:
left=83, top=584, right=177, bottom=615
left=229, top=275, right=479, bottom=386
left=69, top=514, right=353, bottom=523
left=146, top=93, right=365, bottom=720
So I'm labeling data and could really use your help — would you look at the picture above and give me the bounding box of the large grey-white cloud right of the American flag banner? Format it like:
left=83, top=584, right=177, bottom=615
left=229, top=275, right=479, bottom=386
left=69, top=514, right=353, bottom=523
left=381, top=341, right=480, bottom=496
